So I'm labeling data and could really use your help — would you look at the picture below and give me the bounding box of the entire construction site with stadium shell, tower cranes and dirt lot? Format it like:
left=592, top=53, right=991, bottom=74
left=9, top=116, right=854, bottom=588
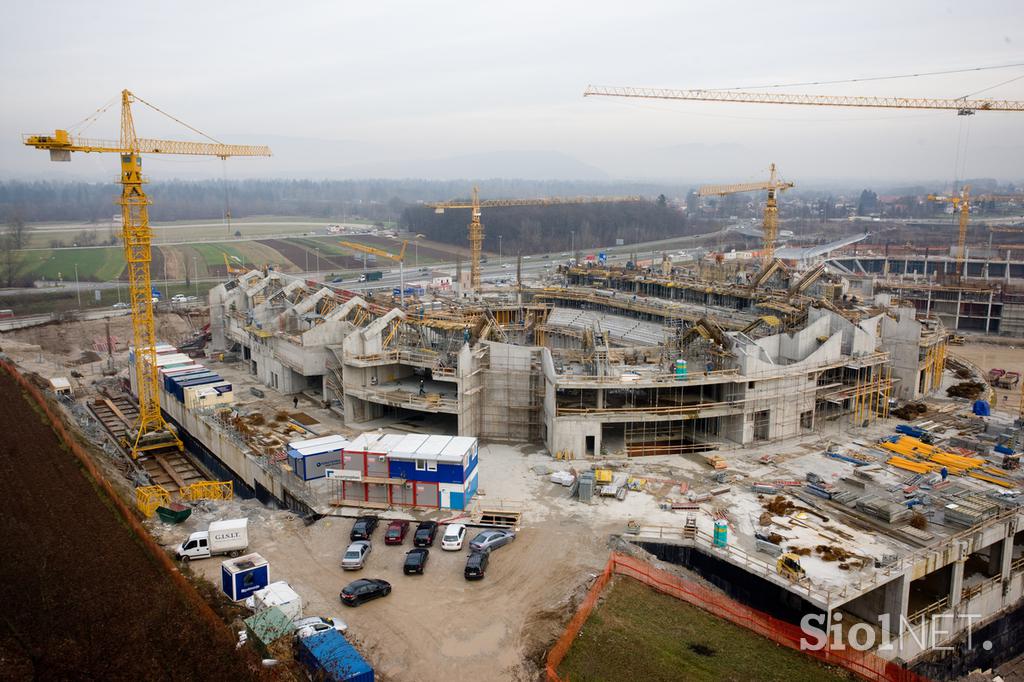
left=6, top=43, right=1024, bottom=682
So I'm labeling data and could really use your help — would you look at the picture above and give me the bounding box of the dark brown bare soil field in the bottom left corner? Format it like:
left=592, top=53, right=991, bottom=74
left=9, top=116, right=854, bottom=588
left=0, top=373, right=268, bottom=680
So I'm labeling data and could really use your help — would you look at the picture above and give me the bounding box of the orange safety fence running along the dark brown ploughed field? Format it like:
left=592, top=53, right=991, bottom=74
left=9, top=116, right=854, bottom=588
left=0, top=359, right=237, bottom=646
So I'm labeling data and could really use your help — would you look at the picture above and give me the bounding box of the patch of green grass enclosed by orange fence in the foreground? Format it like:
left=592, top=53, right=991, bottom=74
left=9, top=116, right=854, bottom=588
left=558, top=578, right=856, bottom=682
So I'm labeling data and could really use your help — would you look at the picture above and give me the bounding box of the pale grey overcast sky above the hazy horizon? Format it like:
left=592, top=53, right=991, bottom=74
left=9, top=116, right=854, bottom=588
left=0, top=0, right=1024, bottom=186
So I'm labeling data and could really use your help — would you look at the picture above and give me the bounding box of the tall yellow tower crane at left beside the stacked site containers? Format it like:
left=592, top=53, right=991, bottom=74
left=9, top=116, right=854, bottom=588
left=23, top=90, right=270, bottom=458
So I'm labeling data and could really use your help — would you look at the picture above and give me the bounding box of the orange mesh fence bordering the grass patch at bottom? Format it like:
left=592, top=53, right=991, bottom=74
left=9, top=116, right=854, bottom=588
left=546, top=552, right=928, bottom=682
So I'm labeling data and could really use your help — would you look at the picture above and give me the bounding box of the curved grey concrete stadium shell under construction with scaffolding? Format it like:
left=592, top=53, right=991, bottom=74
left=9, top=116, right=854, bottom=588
left=210, top=263, right=958, bottom=457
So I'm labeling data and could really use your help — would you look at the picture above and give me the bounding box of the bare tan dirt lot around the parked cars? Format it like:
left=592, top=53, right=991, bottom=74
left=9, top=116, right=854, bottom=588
left=152, top=445, right=623, bottom=681
